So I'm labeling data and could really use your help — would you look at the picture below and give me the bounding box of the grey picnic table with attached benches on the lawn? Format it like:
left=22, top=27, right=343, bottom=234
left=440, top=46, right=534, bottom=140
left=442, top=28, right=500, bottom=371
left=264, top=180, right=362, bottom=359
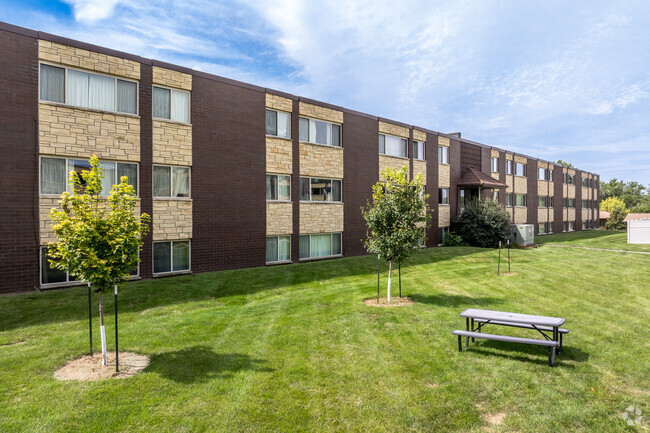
left=452, top=308, right=569, bottom=367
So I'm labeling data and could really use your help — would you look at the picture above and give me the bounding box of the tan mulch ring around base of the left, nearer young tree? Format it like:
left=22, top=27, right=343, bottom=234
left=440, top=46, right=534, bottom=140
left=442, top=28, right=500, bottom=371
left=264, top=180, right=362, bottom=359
left=54, top=352, right=149, bottom=380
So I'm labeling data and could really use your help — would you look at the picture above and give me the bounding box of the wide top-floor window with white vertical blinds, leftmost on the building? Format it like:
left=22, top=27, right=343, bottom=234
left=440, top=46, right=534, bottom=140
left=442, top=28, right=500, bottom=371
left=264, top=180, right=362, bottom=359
left=40, top=64, right=138, bottom=114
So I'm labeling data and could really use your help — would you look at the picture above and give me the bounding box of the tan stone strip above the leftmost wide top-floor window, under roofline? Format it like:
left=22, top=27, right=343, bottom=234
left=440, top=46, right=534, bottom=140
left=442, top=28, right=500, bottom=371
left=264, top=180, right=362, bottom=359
left=38, top=39, right=140, bottom=80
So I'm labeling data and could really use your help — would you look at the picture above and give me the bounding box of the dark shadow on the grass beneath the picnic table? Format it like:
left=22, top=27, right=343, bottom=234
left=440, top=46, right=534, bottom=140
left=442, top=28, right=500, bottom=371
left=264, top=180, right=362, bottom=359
left=463, top=340, right=589, bottom=368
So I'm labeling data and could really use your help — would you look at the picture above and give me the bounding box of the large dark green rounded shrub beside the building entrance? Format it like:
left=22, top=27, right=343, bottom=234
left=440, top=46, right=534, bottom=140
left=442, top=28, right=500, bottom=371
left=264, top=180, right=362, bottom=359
left=453, top=199, right=510, bottom=248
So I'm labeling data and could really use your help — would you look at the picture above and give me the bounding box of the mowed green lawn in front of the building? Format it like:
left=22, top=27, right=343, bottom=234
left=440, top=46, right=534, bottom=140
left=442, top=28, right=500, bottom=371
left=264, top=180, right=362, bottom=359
left=0, top=232, right=650, bottom=432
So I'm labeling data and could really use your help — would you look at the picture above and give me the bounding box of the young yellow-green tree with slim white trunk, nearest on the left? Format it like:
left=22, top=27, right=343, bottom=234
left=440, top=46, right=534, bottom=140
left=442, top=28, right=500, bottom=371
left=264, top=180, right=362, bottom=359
left=48, top=155, right=150, bottom=365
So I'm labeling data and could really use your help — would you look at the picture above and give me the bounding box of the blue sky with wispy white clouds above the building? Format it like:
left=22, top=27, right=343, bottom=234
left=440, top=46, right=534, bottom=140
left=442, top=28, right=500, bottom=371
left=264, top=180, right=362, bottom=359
left=0, top=0, right=650, bottom=186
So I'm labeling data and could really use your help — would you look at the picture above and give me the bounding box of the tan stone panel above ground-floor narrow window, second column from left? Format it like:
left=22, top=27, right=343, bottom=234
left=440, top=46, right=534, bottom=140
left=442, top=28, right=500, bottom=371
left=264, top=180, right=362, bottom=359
left=151, top=199, right=192, bottom=241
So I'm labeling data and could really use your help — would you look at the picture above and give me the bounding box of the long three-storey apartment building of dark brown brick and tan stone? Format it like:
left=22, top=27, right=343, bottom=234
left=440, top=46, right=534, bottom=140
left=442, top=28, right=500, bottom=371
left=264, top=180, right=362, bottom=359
left=0, top=23, right=599, bottom=292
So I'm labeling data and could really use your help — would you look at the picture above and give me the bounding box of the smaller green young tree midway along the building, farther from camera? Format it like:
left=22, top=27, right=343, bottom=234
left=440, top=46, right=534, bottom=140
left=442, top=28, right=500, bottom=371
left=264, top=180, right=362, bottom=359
left=362, top=166, right=430, bottom=302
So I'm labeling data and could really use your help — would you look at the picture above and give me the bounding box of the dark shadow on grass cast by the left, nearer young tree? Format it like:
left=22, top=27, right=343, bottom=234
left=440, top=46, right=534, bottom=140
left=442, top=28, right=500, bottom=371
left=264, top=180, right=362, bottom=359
left=145, top=346, right=274, bottom=383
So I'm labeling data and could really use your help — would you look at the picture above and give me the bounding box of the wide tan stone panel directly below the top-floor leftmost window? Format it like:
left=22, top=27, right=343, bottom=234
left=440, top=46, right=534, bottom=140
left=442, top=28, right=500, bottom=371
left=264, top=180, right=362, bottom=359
left=38, top=102, right=140, bottom=162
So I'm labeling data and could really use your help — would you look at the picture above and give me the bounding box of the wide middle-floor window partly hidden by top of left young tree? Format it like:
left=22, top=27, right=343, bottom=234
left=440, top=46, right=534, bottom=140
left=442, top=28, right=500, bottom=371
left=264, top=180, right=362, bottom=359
left=40, top=157, right=138, bottom=196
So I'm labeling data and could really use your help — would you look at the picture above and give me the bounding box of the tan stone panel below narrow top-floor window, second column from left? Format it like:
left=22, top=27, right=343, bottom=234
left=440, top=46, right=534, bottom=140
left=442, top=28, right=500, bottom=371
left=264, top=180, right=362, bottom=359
left=152, top=120, right=192, bottom=166
